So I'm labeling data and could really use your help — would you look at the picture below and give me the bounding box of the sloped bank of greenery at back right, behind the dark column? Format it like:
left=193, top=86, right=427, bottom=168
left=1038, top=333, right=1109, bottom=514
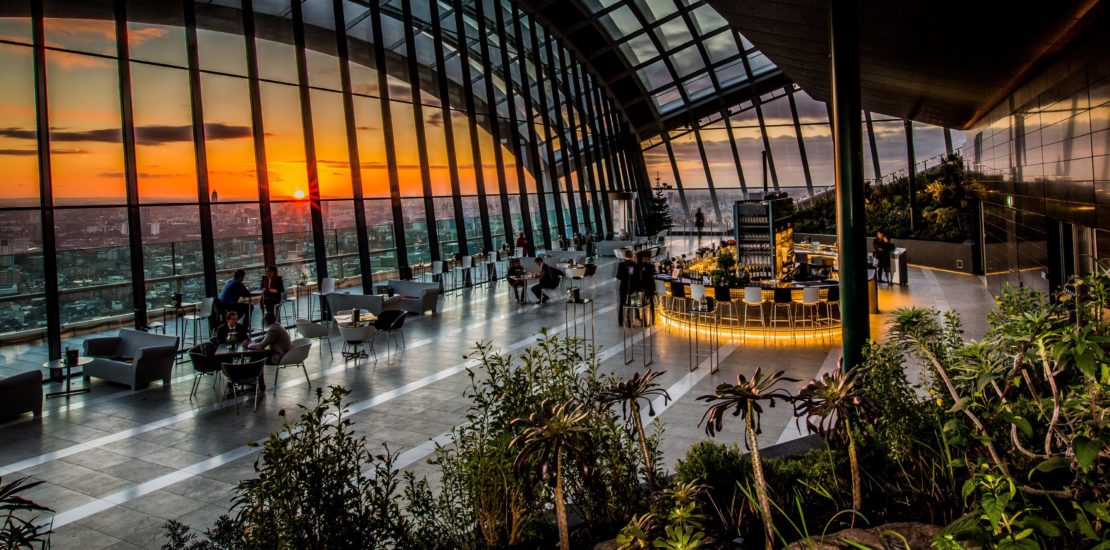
left=794, top=153, right=973, bottom=242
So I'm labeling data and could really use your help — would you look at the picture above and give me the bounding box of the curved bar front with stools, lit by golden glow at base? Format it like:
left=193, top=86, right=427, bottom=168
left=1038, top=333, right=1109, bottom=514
left=656, top=277, right=840, bottom=342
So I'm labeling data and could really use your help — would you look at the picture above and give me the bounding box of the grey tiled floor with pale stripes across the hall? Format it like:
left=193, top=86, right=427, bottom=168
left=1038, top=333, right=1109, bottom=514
left=0, top=242, right=992, bottom=550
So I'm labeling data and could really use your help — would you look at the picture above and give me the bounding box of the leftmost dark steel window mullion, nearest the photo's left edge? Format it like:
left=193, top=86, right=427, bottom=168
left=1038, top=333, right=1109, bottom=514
left=31, top=0, right=60, bottom=360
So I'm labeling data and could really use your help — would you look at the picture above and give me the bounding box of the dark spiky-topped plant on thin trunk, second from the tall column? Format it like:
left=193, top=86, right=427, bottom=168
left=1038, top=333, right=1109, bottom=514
left=697, top=368, right=798, bottom=550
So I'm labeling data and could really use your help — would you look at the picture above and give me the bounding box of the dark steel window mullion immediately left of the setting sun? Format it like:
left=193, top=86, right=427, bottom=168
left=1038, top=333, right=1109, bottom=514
left=242, top=0, right=278, bottom=266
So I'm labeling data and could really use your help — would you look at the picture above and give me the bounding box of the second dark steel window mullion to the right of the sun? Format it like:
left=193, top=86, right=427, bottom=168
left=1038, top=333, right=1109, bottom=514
left=330, top=0, right=374, bottom=294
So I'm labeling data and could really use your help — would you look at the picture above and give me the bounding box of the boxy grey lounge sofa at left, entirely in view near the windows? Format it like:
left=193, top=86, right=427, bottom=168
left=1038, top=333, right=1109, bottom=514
left=83, top=329, right=178, bottom=390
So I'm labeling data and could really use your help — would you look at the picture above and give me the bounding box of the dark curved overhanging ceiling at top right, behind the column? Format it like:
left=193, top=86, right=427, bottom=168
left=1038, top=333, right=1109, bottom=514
left=709, top=0, right=1108, bottom=129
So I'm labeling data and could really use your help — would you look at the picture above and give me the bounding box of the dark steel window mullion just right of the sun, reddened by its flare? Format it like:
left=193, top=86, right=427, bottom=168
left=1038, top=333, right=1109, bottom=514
left=292, top=0, right=326, bottom=281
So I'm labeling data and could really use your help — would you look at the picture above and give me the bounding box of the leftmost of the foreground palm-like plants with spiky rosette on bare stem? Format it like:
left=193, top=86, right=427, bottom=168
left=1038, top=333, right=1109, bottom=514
left=508, top=399, right=592, bottom=550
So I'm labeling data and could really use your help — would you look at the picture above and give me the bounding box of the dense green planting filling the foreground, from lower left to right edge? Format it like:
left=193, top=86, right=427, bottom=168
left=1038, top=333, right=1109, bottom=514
left=165, top=270, right=1110, bottom=550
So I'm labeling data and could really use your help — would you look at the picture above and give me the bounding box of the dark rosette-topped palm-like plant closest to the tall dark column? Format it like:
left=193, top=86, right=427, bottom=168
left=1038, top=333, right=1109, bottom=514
left=794, top=361, right=862, bottom=521
